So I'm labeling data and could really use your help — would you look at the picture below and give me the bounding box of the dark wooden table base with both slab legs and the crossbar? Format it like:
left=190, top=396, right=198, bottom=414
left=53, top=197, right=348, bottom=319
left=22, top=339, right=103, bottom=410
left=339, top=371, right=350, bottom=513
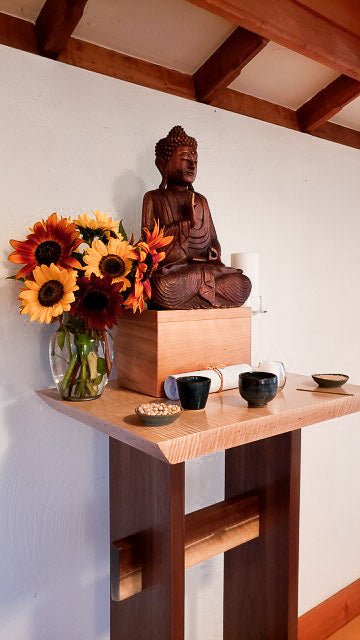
left=110, top=431, right=300, bottom=640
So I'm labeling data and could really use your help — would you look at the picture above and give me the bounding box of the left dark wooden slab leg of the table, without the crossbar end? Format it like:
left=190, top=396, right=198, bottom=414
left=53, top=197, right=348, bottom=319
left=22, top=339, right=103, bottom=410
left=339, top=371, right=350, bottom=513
left=110, top=438, right=185, bottom=640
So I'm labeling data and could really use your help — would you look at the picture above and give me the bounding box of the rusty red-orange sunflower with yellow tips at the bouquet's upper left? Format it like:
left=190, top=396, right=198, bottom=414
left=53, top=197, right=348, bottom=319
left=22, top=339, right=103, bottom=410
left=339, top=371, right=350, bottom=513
left=9, top=213, right=82, bottom=278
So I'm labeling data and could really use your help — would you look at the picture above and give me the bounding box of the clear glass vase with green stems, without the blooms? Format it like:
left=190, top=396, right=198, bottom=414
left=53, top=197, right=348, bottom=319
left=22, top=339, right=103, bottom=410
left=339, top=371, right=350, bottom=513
left=49, top=325, right=113, bottom=402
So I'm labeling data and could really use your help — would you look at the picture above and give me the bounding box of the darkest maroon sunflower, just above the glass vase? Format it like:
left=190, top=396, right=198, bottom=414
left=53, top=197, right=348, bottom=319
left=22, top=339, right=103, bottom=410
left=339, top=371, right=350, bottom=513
left=70, top=273, right=123, bottom=331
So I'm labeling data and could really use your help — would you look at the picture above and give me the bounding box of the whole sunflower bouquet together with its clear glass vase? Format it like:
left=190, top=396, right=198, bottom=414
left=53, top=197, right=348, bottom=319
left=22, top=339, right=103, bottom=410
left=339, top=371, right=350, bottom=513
left=8, top=211, right=172, bottom=400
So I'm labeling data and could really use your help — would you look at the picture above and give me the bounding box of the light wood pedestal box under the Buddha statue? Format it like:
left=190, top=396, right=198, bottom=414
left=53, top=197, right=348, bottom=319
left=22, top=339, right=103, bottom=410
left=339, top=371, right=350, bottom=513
left=115, top=307, right=251, bottom=398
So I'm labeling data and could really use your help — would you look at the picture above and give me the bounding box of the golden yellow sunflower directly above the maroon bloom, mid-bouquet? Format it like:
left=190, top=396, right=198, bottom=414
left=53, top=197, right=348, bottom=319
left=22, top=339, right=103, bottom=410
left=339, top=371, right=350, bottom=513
left=83, top=238, right=138, bottom=291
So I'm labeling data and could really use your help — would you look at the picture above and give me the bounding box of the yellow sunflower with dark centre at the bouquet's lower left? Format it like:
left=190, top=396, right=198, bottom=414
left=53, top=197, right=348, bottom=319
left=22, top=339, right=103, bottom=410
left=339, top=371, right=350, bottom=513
left=19, top=263, right=79, bottom=324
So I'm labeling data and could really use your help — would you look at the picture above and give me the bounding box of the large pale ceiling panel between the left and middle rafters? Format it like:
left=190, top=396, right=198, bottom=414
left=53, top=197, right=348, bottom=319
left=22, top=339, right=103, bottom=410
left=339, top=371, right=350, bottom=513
left=73, top=0, right=235, bottom=74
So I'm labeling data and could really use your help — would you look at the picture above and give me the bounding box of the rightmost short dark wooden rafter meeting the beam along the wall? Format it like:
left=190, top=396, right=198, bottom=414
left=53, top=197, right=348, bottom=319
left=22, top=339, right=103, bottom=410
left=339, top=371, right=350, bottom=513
left=297, top=75, right=360, bottom=131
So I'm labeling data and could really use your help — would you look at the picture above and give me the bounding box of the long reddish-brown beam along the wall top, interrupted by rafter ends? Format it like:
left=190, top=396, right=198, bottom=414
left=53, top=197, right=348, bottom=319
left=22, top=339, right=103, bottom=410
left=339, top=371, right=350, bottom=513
left=0, top=13, right=360, bottom=149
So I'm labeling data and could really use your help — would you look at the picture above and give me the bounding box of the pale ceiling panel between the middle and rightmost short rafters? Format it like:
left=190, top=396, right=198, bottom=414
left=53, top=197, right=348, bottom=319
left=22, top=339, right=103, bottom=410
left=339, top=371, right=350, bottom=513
left=231, top=42, right=339, bottom=109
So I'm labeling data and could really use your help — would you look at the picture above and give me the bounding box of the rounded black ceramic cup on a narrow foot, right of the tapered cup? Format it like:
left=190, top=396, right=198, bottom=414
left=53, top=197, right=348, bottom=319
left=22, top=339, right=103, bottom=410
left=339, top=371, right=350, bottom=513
left=239, top=371, right=278, bottom=407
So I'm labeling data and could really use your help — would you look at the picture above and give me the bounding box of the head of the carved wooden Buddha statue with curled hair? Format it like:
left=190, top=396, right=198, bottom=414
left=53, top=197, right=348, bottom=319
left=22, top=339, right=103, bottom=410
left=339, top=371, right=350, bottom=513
left=155, top=125, right=198, bottom=189
